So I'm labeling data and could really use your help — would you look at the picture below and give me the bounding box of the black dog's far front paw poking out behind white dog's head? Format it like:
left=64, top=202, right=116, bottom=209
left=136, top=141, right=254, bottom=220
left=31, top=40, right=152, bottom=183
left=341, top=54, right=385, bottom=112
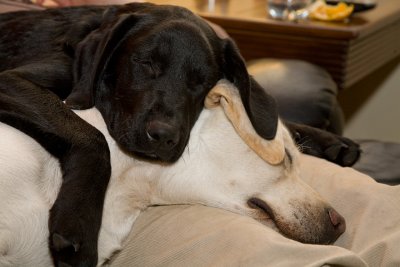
left=285, top=121, right=361, bottom=166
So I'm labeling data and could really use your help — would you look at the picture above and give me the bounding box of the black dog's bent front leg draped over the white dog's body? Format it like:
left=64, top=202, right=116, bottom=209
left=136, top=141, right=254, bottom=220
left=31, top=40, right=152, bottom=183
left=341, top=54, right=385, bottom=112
left=0, top=72, right=111, bottom=266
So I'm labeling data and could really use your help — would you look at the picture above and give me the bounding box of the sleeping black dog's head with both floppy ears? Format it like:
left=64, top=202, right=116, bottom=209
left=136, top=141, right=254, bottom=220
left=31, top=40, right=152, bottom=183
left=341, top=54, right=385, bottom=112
left=66, top=3, right=277, bottom=161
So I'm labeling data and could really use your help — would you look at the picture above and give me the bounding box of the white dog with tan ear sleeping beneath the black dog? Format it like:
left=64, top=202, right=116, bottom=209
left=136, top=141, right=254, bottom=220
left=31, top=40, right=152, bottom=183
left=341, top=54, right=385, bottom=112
left=0, top=81, right=345, bottom=266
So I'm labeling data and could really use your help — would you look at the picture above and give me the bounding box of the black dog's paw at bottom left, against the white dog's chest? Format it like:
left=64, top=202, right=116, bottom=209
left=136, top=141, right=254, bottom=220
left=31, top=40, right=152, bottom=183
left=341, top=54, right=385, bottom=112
left=49, top=205, right=98, bottom=267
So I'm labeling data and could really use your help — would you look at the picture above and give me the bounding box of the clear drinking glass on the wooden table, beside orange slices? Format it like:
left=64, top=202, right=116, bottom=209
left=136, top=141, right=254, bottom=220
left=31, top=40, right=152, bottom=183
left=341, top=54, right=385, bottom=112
left=267, top=0, right=313, bottom=20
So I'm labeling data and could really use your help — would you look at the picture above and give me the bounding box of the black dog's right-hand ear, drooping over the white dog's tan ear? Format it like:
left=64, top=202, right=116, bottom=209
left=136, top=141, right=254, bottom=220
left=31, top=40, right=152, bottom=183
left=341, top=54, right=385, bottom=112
left=222, top=39, right=278, bottom=140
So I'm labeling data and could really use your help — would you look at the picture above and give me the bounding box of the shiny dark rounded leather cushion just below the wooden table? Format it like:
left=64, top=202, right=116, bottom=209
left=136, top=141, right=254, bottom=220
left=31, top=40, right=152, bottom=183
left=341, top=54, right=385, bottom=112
left=248, top=59, right=343, bottom=134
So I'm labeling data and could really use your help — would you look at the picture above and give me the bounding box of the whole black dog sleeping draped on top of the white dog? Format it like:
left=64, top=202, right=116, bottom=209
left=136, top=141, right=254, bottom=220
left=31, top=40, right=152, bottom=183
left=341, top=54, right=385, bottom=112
left=0, top=4, right=359, bottom=266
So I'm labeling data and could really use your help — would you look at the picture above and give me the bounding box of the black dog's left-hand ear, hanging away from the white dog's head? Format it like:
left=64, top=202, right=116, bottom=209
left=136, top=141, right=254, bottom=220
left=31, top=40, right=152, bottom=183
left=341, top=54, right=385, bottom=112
left=65, top=8, right=140, bottom=109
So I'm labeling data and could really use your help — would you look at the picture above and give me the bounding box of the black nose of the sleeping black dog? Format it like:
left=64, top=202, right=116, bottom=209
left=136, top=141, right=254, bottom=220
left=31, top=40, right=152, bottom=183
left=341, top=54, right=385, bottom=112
left=146, top=120, right=179, bottom=148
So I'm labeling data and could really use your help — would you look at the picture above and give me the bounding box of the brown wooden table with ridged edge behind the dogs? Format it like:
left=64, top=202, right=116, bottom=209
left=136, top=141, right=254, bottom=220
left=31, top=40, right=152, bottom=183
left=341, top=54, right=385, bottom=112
left=138, top=0, right=400, bottom=88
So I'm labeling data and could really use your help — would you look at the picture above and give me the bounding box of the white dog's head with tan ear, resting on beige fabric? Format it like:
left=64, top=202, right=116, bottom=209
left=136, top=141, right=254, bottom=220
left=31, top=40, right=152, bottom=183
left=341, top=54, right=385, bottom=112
left=92, top=81, right=345, bottom=247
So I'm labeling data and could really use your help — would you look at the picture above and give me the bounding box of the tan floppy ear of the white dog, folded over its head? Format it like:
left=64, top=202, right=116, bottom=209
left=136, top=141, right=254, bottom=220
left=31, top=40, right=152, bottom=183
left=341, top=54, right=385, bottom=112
left=205, top=80, right=285, bottom=165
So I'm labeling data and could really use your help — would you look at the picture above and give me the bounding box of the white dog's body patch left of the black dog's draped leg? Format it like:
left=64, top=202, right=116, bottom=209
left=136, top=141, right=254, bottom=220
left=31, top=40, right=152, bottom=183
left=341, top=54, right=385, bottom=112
left=0, top=124, right=61, bottom=266
